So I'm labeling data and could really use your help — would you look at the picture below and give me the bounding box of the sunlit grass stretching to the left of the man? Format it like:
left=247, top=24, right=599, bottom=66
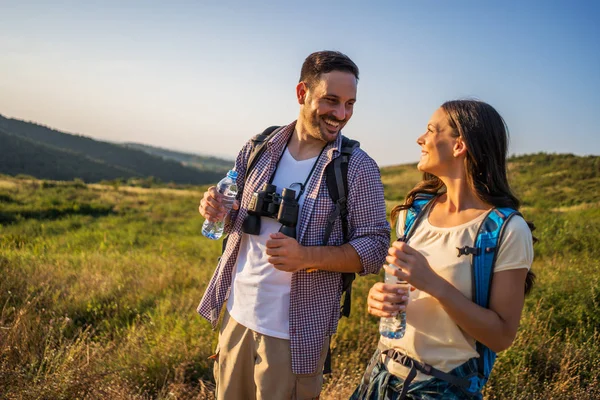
left=0, top=181, right=218, bottom=399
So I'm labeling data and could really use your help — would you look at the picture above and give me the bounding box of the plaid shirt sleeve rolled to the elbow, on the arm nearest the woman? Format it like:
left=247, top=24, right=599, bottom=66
left=348, top=150, right=390, bottom=275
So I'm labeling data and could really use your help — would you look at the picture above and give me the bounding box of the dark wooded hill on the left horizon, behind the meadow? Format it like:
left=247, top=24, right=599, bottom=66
left=0, top=115, right=227, bottom=184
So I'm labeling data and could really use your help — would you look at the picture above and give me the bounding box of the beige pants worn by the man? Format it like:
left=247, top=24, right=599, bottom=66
left=214, top=310, right=329, bottom=400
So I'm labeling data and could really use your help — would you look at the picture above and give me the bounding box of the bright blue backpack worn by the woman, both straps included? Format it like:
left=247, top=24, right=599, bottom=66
left=398, top=194, right=521, bottom=393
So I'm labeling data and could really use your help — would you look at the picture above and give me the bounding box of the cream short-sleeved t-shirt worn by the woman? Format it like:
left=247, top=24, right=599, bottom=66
left=380, top=206, right=533, bottom=380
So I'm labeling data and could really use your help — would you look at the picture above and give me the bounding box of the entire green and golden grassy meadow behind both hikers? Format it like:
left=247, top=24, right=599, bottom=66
left=0, top=154, right=600, bottom=399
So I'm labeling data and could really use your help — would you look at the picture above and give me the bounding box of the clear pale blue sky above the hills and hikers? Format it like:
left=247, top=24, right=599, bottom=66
left=0, top=0, right=600, bottom=165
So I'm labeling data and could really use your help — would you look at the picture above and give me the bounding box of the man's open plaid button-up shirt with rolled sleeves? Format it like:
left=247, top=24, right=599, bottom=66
left=198, top=122, right=390, bottom=374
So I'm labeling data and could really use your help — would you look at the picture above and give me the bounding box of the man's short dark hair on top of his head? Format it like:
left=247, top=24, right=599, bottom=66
left=300, top=50, right=358, bottom=87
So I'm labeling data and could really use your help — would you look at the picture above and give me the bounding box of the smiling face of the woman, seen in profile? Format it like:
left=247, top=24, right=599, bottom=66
left=417, top=108, right=460, bottom=177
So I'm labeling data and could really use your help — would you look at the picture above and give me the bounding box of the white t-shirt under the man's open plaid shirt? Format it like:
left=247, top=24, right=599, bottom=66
left=227, top=148, right=317, bottom=339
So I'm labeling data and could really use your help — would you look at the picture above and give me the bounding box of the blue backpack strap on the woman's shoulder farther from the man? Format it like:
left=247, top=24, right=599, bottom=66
left=472, top=207, right=521, bottom=386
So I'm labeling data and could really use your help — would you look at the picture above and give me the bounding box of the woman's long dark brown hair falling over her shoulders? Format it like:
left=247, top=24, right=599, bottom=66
left=391, top=100, right=537, bottom=293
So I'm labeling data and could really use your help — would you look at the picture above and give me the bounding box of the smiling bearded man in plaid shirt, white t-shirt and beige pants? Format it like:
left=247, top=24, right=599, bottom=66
left=198, top=51, right=390, bottom=400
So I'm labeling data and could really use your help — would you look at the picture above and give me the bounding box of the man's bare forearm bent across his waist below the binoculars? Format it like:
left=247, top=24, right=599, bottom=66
left=305, top=243, right=363, bottom=273
